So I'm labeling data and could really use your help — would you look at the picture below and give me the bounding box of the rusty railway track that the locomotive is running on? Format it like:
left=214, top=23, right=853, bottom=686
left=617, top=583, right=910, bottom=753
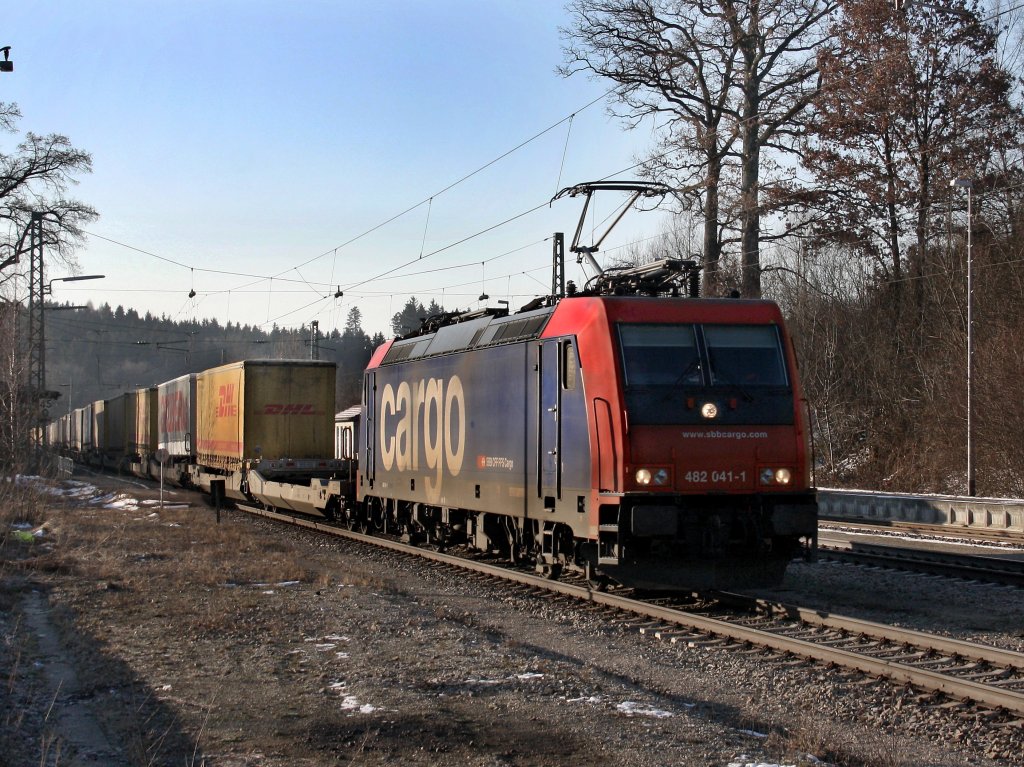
left=239, top=506, right=1024, bottom=720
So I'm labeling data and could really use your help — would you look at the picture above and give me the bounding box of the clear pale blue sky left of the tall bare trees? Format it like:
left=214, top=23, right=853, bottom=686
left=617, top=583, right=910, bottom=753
left=0, top=0, right=662, bottom=333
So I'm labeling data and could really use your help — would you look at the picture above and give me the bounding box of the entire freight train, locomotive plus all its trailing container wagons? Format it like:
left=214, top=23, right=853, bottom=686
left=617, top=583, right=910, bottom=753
left=44, top=182, right=817, bottom=590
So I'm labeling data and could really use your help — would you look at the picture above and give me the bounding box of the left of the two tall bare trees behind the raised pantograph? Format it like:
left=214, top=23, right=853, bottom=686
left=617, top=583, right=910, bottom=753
left=562, top=0, right=739, bottom=293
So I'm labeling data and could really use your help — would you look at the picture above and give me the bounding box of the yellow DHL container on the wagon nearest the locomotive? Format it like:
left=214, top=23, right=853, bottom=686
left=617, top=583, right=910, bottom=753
left=196, top=359, right=337, bottom=471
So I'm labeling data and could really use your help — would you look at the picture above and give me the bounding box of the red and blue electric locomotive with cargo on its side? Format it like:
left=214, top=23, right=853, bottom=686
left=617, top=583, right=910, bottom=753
left=356, top=179, right=817, bottom=589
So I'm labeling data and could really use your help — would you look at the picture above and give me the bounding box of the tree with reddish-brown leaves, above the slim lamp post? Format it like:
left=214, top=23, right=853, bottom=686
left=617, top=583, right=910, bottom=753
left=805, top=0, right=1021, bottom=306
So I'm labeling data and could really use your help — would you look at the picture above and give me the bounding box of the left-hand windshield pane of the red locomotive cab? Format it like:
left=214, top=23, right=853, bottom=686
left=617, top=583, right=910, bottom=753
left=618, top=325, right=700, bottom=386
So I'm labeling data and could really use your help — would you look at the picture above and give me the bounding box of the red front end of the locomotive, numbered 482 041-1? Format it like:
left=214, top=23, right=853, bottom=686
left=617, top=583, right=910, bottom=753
left=544, top=296, right=817, bottom=589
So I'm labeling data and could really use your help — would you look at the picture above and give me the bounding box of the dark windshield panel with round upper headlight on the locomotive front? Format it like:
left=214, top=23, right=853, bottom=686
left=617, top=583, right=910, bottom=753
left=618, top=324, right=793, bottom=425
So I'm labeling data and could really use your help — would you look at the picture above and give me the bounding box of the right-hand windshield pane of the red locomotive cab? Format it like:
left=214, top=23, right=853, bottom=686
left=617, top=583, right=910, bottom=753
left=703, top=325, right=787, bottom=386
